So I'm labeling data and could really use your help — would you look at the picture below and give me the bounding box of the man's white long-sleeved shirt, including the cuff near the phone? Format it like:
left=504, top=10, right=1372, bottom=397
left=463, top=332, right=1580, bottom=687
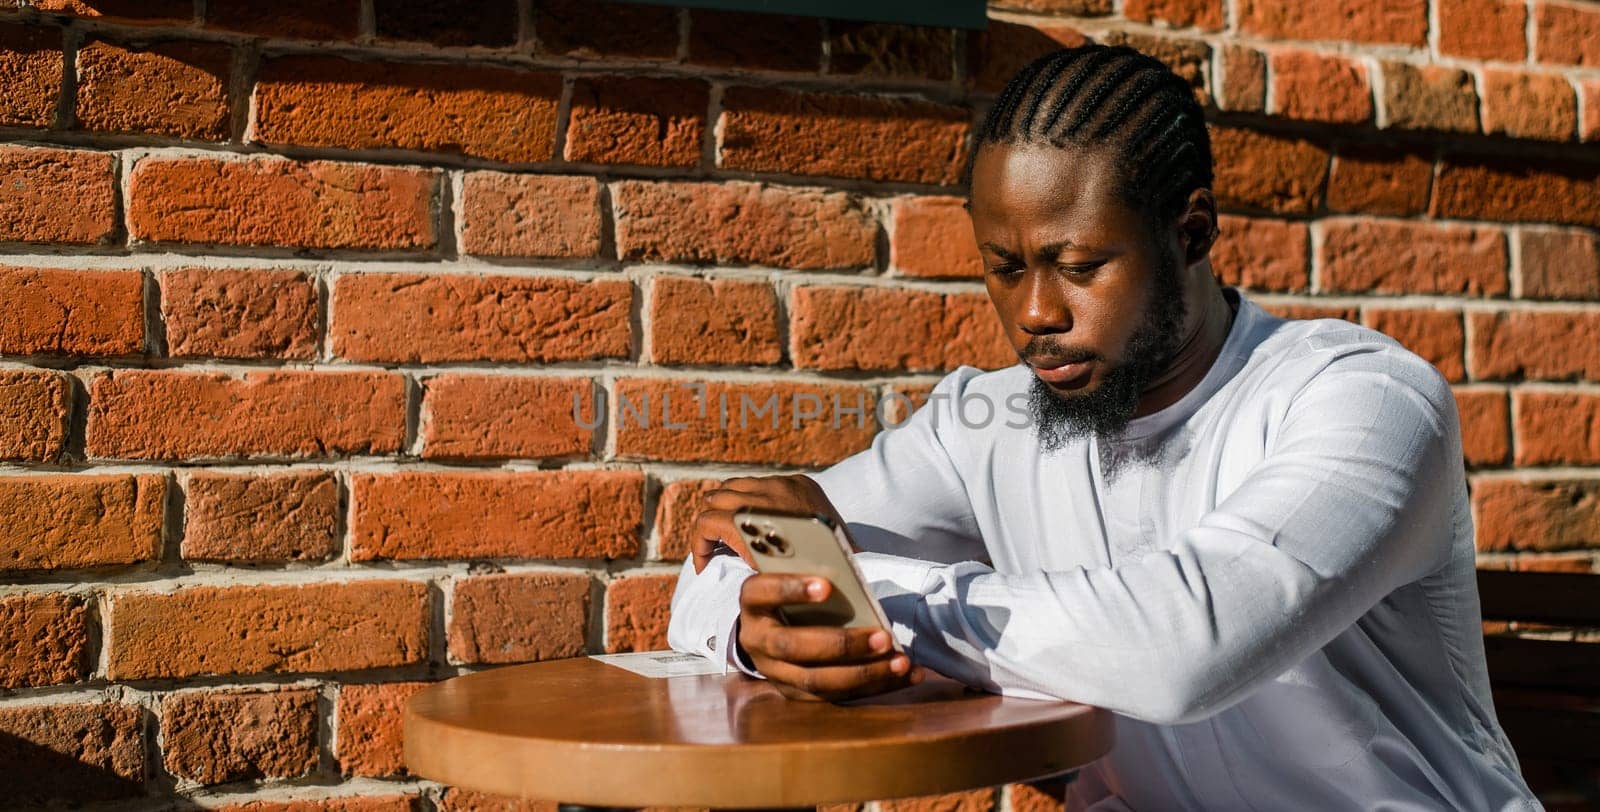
left=669, top=289, right=1541, bottom=810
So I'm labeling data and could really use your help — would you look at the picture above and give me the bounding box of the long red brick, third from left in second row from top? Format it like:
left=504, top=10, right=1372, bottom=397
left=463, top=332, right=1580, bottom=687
left=250, top=56, right=562, bottom=163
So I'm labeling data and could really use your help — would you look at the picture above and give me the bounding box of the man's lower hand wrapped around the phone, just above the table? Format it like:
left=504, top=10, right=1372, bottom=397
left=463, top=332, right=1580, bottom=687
left=739, top=572, right=925, bottom=702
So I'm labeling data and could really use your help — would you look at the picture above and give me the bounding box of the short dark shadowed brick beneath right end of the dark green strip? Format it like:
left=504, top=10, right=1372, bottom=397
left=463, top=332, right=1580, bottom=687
left=827, top=19, right=955, bottom=82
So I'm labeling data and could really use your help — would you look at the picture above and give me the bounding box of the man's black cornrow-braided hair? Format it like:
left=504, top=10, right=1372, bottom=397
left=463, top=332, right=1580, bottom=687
left=962, top=43, right=1213, bottom=238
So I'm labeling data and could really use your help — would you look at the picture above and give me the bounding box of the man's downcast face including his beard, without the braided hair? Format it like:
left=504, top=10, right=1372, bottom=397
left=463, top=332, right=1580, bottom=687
left=970, top=144, right=1186, bottom=449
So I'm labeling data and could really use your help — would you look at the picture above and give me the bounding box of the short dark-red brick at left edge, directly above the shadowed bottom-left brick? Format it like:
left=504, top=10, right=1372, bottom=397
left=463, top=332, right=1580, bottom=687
left=0, top=593, right=90, bottom=689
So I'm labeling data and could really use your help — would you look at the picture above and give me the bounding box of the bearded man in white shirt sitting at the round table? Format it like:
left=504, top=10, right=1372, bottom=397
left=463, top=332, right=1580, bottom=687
left=669, top=45, right=1538, bottom=810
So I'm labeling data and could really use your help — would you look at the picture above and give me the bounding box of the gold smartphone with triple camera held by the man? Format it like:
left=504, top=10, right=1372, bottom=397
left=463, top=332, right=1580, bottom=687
left=733, top=510, right=904, bottom=654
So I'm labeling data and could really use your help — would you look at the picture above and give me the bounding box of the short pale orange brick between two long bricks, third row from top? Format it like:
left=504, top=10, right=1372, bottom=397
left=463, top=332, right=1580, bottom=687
left=461, top=173, right=602, bottom=259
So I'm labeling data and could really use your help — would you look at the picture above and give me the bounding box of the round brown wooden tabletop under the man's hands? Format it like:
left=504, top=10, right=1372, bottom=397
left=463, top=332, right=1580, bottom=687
left=405, top=657, right=1112, bottom=809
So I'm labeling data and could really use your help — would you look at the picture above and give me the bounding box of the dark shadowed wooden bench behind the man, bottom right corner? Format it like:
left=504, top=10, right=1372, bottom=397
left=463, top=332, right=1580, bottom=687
left=1478, top=569, right=1600, bottom=809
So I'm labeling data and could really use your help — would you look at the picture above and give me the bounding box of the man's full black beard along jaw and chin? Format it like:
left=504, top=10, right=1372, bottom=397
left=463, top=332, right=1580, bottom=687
left=1027, top=251, right=1186, bottom=452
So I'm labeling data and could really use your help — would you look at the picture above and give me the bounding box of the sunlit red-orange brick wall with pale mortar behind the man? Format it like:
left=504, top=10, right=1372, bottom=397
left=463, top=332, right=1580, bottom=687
left=0, top=0, right=1600, bottom=810
